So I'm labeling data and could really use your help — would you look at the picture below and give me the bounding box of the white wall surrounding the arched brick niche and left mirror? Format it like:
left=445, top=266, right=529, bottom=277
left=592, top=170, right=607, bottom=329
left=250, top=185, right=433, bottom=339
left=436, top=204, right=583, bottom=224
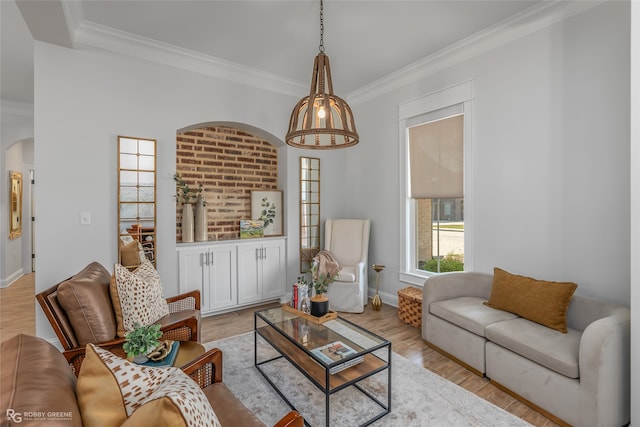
left=35, top=42, right=297, bottom=338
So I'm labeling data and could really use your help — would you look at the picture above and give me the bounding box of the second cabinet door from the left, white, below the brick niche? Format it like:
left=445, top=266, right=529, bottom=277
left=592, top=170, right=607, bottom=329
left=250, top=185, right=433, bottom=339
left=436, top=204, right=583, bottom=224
left=208, top=245, right=238, bottom=310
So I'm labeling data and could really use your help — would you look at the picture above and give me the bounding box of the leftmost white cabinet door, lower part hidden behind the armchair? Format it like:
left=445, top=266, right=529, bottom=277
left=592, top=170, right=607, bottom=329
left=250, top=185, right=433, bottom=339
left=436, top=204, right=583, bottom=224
left=178, top=248, right=211, bottom=311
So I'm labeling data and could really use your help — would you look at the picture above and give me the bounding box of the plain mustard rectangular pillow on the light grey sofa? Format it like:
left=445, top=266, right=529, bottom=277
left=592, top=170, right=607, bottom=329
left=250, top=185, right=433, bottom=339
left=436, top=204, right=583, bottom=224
left=485, top=267, right=578, bottom=334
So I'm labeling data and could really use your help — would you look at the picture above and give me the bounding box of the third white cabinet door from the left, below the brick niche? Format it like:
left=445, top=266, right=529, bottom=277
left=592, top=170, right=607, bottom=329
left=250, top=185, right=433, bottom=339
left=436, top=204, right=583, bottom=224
left=238, top=243, right=263, bottom=304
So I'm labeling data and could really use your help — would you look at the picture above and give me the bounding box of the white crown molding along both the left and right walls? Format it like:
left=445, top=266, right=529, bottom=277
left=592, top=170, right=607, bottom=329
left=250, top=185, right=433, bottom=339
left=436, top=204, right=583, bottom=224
left=63, top=0, right=607, bottom=104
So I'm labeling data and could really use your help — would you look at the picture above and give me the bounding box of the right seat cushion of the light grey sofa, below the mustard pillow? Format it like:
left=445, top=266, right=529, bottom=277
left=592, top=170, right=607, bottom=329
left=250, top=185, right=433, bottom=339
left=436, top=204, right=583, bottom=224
left=485, top=318, right=582, bottom=378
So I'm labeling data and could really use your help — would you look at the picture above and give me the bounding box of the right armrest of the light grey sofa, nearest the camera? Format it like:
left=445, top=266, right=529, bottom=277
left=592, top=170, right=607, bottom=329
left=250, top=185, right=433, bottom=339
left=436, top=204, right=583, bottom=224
left=578, top=307, right=631, bottom=425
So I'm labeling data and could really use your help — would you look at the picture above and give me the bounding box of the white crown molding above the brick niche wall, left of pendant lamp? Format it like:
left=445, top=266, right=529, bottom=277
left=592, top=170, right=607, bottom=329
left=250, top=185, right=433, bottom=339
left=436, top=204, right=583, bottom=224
left=75, top=21, right=307, bottom=97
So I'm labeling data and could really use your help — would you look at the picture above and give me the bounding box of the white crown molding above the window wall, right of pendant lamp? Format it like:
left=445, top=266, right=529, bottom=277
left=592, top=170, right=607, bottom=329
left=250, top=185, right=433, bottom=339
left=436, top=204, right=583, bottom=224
left=345, top=0, right=608, bottom=105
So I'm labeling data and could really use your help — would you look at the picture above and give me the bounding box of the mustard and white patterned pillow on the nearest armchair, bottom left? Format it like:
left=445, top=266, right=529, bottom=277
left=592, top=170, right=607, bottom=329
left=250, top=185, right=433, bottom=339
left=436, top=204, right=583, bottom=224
left=77, top=344, right=220, bottom=427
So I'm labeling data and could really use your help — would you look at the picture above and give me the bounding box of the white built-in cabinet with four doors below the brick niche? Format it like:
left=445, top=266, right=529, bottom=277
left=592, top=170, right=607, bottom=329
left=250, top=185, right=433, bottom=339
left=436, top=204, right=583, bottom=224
left=177, top=238, right=287, bottom=315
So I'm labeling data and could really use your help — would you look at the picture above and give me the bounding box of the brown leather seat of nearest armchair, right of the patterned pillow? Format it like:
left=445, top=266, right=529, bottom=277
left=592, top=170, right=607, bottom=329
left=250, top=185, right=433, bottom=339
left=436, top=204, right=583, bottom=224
left=204, top=383, right=264, bottom=427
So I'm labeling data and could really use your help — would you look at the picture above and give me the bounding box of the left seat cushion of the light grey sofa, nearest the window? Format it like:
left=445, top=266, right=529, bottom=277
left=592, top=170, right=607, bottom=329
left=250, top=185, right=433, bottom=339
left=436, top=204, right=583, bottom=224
left=429, top=297, right=518, bottom=337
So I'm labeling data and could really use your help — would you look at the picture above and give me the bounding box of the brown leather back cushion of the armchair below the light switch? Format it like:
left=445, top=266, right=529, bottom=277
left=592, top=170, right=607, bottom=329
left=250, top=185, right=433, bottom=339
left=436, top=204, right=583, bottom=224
left=57, top=262, right=116, bottom=346
